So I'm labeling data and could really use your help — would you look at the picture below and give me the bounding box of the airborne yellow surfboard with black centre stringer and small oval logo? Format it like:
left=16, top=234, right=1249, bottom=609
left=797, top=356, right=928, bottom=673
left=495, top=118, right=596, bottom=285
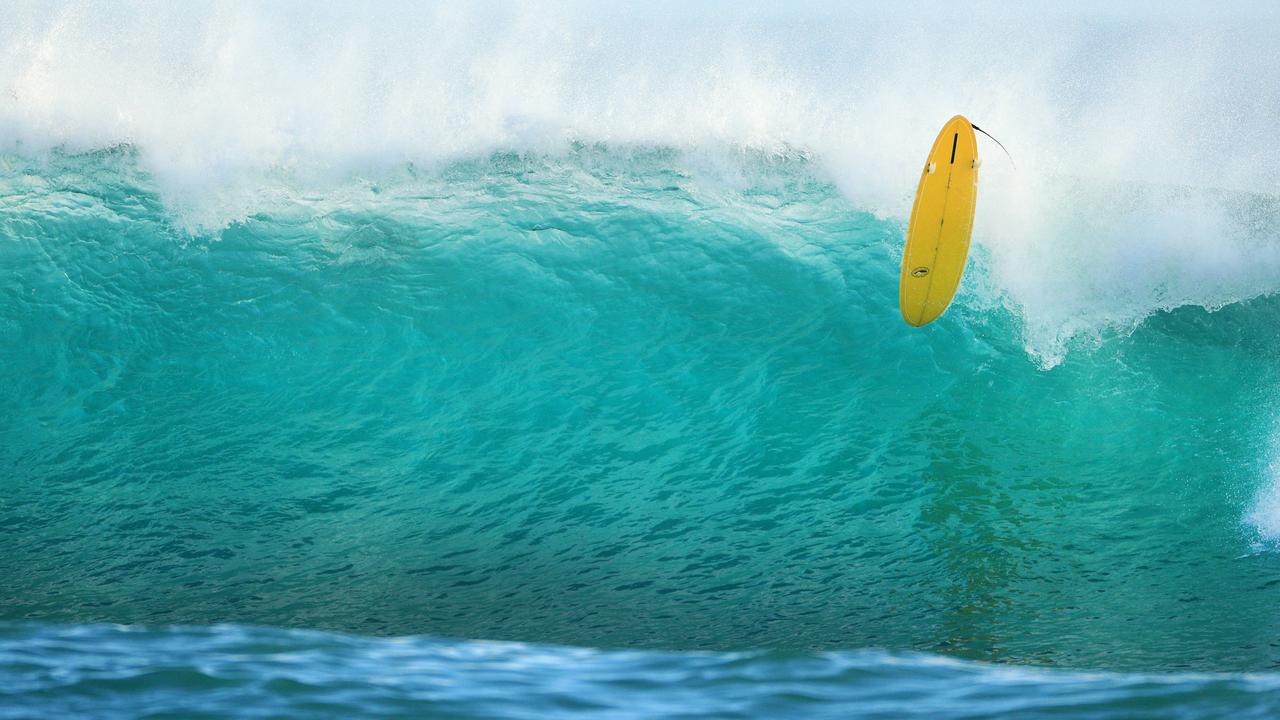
left=897, top=115, right=982, bottom=327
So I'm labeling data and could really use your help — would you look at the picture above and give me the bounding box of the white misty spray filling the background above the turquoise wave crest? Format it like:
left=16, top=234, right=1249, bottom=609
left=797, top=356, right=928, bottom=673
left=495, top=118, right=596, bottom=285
left=0, top=1, right=1280, bottom=365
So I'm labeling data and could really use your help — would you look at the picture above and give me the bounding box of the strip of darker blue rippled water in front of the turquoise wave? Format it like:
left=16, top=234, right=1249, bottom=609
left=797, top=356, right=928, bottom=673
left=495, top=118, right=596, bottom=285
left=0, top=625, right=1280, bottom=720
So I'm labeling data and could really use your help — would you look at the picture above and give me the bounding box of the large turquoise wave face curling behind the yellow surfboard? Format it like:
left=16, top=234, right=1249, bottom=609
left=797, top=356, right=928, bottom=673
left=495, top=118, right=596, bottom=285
left=0, top=149, right=1280, bottom=670
